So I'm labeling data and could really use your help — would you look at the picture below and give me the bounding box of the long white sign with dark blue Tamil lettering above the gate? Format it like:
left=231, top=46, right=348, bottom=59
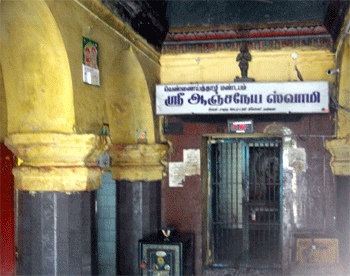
left=156, top=81, right=329, bottom=115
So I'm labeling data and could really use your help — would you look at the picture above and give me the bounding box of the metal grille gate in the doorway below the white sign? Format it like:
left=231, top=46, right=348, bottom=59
left=209, top=138, right=282, bottom=268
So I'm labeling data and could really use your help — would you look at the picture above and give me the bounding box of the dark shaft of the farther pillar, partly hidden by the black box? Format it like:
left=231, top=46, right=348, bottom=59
left=117, top=181, right=161, bottom=275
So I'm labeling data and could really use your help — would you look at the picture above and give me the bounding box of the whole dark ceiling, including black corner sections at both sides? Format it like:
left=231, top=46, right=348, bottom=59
left=100, top=0, right=349, bottom=49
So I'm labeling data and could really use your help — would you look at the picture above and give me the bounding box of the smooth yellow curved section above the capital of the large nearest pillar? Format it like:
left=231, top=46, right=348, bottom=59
left=0, top=0, right=75, bottom=134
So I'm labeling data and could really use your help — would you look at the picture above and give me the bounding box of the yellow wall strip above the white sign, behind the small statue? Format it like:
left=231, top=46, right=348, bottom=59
left=160, top=48, right=334, bottom=84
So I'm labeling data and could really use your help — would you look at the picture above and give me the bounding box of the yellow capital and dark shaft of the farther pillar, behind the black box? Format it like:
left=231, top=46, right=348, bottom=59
left=108, top=144, right=169, bottom=275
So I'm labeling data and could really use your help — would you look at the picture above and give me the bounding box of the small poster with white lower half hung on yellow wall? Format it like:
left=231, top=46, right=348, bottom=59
left=83, top=37, right=100, bottom=86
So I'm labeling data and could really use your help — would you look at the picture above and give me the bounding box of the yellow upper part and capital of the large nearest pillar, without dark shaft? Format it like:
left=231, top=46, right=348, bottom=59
left=0, top=0, right=112, bottom=191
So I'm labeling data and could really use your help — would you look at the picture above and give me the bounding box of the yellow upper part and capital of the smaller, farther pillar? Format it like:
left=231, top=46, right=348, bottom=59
left=106, top=48, right=168, bottom=181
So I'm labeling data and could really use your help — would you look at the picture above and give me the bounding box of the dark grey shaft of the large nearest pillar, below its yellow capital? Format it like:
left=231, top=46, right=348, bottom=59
left=17, top=191, right=97, bottom=275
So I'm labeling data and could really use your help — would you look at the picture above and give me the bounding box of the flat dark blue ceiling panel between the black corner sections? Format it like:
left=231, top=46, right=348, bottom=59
left=167, top=0, right=329, bottom=28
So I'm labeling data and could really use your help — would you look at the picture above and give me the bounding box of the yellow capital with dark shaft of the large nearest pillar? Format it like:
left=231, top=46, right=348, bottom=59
left=5, top=133, right=108, bottom=275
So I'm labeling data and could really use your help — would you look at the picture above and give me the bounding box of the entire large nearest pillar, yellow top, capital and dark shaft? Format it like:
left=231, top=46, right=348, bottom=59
left=0, top=0, right=110, bottom=275
